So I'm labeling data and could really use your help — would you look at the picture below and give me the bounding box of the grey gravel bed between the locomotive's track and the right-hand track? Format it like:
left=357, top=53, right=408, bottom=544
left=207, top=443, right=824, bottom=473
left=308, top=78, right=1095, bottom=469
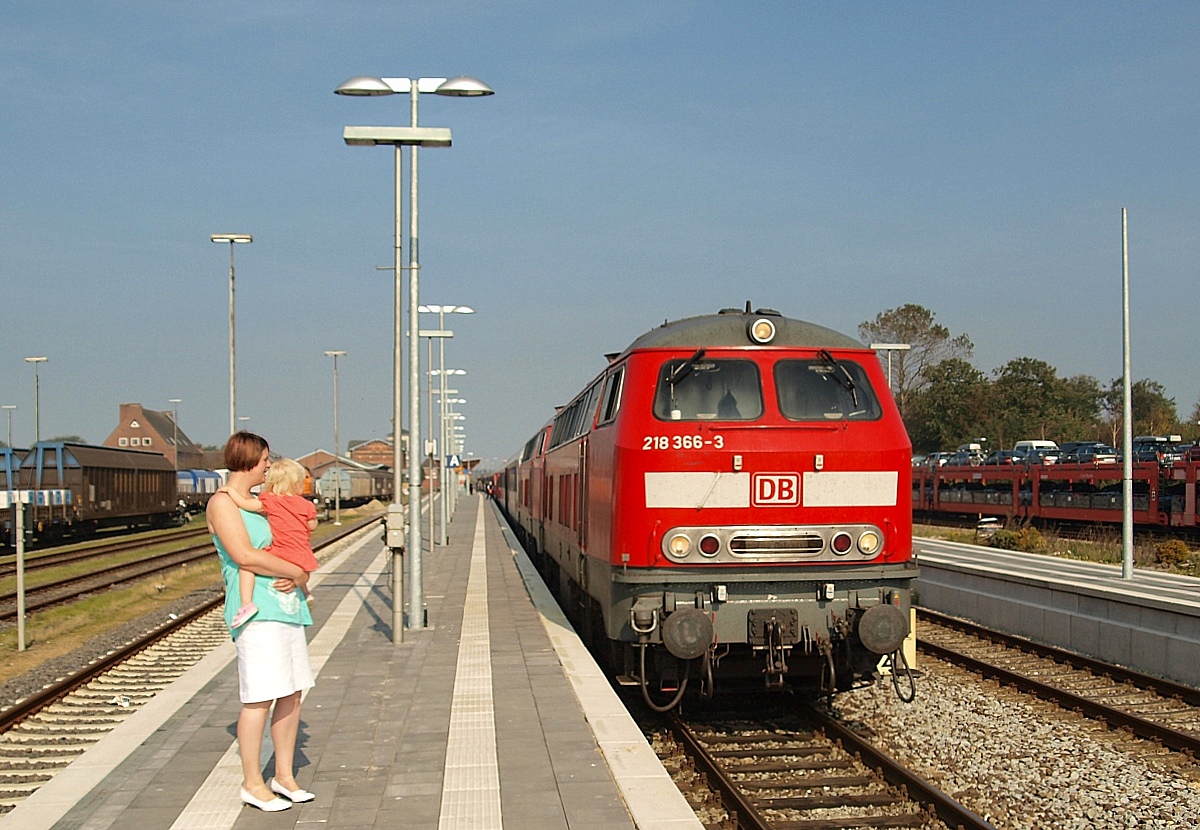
left=835, top=660, right=1200, bottom=830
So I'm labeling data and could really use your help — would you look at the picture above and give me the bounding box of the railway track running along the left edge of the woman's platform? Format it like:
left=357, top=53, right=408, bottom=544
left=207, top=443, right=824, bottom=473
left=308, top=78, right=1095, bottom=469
left=0, top=516, right=378, bottom=814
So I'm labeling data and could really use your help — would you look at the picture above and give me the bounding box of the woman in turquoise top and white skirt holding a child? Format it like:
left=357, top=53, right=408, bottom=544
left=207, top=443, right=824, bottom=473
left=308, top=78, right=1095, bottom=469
left=208, top=432, right=314, bottom=812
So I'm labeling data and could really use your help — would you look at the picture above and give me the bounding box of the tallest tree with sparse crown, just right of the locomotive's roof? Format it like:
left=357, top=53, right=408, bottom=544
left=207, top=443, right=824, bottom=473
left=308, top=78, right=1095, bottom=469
left=858, top=302, right=974, bottom=415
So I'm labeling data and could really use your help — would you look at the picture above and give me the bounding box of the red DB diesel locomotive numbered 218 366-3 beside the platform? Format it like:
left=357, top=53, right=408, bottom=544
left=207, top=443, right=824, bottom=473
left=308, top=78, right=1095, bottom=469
left=493, top=303, right=917, bottom=709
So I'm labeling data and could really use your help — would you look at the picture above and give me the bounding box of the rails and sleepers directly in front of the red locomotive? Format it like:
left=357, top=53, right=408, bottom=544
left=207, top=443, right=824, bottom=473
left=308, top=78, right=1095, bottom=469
left=668, top=706, right=992, bottom=830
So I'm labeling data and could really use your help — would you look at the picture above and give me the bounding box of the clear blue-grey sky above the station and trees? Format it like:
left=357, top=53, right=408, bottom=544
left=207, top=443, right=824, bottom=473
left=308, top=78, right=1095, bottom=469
left=0, top=0, right=1200, bottom=459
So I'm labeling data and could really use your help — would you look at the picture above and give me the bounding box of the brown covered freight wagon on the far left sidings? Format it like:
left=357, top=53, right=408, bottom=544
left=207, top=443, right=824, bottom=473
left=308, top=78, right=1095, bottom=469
left=17, top=441, right=179, bottom=543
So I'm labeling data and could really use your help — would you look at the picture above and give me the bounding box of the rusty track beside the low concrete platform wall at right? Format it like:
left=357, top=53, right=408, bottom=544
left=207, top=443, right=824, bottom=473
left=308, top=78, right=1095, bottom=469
left=918, top=609, right=1200, bottom=757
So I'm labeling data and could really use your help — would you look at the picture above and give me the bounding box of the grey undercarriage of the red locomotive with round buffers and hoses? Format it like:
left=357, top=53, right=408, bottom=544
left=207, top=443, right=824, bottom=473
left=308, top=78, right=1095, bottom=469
left=539, top=537, right=916, bottom=710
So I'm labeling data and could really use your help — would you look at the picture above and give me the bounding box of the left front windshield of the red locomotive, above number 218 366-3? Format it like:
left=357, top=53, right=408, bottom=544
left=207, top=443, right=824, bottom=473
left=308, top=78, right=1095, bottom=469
left=654, top=351, right=762, bottom=421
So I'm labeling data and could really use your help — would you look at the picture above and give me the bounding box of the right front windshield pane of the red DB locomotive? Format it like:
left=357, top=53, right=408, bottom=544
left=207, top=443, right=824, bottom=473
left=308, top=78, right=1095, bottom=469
left=775, top=353, right=883, bottom=421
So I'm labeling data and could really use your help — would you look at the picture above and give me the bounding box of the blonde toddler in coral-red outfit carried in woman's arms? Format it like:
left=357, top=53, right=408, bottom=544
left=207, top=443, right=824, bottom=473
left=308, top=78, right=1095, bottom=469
left=217, top=458, right=318, bottom=628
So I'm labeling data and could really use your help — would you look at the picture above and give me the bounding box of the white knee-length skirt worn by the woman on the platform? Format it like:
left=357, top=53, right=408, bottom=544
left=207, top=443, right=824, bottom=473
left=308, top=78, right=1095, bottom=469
left=234, top=620, right=316, bottom=703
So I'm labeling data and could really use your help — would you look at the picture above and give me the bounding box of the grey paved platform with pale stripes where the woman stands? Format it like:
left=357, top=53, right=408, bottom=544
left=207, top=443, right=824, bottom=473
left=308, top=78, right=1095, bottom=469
left=7, top=497, right=701, bottom=830
